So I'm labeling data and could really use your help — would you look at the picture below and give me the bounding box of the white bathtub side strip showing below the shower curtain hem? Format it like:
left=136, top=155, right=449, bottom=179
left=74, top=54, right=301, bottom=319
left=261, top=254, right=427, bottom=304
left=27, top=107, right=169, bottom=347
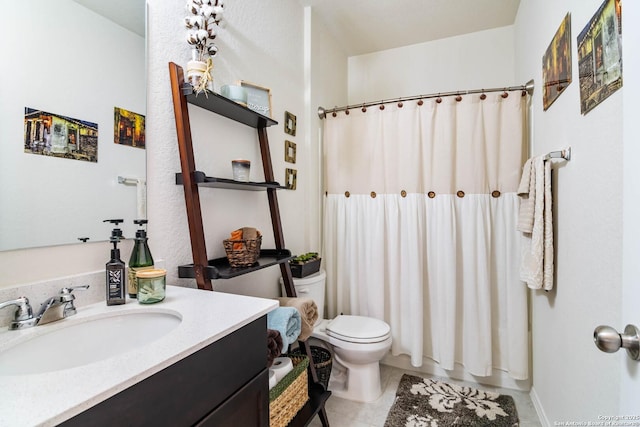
left=380, top=354, right=531, bottom=391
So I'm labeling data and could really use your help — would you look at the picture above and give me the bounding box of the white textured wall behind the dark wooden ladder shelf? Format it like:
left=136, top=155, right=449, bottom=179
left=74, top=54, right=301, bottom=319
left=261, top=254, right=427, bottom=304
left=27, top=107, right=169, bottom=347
left=147, top=0, right=315, bottom=296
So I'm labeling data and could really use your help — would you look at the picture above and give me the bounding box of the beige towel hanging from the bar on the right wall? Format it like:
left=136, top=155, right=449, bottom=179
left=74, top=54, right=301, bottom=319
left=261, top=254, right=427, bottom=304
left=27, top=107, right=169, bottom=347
left=518, top=156, right=553, bottom=291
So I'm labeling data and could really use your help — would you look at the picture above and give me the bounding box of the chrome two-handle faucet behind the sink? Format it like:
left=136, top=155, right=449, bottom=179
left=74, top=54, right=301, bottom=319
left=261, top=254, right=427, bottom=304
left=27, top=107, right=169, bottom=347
left=0, top=285, right=89, bottom=330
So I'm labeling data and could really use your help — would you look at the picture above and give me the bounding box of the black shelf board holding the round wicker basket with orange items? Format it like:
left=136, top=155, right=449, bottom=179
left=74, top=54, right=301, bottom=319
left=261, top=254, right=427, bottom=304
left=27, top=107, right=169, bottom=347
left=178, top=249, right=293, bottom=280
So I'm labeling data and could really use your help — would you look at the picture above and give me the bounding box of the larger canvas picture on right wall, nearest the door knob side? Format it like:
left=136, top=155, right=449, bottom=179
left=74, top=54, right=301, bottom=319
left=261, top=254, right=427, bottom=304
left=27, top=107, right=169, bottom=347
left=578, top=0, right=622, bottom=114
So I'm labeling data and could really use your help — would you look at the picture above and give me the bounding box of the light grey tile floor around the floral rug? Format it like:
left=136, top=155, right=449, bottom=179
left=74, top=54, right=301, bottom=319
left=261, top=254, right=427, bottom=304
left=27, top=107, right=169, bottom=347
left=309, top=365, right=541, bottom=427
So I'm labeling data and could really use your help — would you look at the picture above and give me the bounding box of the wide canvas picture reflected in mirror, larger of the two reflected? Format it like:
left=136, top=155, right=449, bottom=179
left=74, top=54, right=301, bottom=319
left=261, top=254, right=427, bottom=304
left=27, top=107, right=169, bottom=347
left=24, top=107, right=98, bottom=163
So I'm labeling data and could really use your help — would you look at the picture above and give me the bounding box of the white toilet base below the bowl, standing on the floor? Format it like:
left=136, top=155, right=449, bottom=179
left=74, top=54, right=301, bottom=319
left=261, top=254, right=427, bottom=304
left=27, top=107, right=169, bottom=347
left=329, top=353, right=382, bottom=402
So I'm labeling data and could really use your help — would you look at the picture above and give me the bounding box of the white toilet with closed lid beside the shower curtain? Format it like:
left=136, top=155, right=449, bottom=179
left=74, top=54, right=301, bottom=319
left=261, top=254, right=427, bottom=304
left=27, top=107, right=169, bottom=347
left=284, top=270, right=391, bottom=402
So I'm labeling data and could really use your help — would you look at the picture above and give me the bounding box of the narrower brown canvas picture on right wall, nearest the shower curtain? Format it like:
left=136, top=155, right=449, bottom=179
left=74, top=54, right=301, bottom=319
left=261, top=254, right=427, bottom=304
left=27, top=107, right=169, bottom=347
left=542, top=13, right=571, bottom=111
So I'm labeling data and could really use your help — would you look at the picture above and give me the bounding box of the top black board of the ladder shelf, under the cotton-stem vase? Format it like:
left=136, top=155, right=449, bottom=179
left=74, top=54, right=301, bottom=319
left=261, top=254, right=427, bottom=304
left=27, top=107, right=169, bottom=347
left=182, top=83, right=278, bottom=129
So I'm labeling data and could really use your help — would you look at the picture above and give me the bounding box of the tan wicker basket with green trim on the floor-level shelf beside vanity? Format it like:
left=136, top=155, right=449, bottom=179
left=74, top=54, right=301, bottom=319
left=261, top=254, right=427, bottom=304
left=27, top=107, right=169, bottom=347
left=269, top=354, right=309, bottom=427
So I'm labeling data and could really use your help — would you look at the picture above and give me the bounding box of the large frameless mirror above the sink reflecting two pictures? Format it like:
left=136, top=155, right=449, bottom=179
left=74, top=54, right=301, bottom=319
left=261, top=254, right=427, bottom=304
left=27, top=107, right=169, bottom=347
left=0, top=0, right=146, bottom=251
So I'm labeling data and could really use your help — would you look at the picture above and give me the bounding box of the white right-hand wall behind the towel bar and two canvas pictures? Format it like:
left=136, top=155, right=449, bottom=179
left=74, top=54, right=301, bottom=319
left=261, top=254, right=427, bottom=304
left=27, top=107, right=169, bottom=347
left=515, top=0, right=633, bottom=424
